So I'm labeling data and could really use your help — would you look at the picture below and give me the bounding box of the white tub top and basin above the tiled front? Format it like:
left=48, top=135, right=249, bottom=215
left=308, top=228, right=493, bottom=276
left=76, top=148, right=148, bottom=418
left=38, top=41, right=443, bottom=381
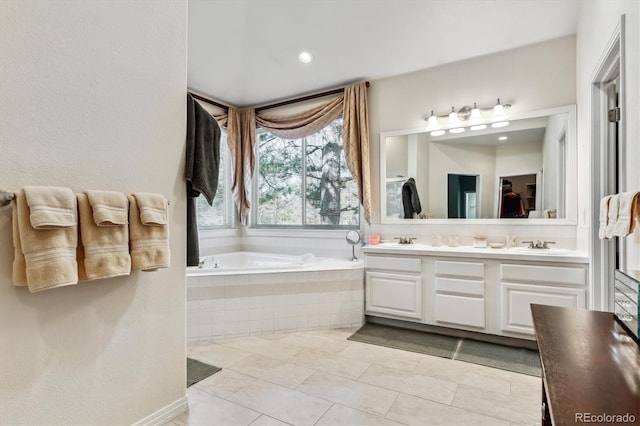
left=187, top=251, right=362, bottom=277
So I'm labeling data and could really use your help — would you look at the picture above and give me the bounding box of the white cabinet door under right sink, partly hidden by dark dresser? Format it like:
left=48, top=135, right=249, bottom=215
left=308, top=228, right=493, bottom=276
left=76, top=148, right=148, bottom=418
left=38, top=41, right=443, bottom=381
left=500, top=282, right=585, bottom=336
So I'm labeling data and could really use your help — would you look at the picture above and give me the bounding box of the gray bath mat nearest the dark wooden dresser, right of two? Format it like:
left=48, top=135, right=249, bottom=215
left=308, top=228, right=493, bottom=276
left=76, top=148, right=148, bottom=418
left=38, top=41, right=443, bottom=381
left=454, top=339, right=542, bottom=377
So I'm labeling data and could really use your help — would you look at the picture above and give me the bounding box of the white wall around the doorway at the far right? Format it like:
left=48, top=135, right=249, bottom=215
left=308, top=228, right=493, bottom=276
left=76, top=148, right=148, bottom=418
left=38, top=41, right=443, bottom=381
left=576, top=0, right=640, bottom=269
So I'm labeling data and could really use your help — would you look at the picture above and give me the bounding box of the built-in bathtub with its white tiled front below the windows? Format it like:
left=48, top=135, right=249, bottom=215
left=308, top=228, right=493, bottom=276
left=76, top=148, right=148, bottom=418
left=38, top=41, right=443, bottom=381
left=187, top=252, right=364, bottom=341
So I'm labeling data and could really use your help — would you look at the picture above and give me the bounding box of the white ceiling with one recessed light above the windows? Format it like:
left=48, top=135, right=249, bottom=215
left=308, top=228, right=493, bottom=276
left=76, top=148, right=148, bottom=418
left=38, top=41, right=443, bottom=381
left=187, top=0, right=580, bottom=107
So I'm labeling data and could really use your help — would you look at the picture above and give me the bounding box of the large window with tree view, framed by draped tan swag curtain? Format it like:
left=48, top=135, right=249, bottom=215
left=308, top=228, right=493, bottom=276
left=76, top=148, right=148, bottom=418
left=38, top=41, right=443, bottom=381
left=252, top=117, right=360, bottom=228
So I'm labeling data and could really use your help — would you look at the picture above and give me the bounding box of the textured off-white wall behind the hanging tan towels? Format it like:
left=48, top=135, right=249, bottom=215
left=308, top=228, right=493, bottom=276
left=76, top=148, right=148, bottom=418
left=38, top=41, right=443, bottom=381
left=0, top=0, right=187, bottom=425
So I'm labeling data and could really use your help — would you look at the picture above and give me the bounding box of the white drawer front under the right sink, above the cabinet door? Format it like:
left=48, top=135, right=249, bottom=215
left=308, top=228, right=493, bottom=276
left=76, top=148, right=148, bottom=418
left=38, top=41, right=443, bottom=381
left=500, top=264, right=586, bottom=286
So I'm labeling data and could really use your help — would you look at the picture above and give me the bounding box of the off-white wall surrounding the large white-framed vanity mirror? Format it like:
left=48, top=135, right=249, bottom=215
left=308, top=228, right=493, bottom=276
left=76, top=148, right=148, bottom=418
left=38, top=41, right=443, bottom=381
left=367, top=36, right=576, bottom=243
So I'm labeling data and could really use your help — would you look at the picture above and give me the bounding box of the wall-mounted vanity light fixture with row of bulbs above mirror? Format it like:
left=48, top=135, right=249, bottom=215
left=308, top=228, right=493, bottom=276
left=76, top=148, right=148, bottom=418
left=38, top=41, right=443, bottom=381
left=424, top=98, right=511, bottom=131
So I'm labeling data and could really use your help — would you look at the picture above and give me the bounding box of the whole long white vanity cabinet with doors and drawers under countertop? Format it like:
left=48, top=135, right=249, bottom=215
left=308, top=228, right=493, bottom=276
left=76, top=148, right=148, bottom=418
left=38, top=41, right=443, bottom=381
left=364, top=245, right=588, bottom=340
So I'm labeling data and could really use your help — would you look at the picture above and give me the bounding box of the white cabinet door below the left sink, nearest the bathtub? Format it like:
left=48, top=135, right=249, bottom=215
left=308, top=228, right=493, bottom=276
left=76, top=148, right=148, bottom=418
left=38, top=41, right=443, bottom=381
left=365, top=272, right=422, bottom=321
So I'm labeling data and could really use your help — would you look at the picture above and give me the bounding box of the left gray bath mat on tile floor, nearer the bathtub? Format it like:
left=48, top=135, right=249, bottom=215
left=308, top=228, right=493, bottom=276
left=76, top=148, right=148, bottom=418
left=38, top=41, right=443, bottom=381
left=349, top=323, right=459, bottom=358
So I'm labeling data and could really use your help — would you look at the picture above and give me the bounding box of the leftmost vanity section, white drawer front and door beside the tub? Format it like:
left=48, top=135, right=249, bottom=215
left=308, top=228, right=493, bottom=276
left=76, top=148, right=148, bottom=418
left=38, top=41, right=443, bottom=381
left=365, top=256, right=423, bottom=322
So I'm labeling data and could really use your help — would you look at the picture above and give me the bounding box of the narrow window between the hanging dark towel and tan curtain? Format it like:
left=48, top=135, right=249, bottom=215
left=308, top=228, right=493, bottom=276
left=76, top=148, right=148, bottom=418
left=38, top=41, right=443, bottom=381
left=196, top=129, right=232, bottom=229
